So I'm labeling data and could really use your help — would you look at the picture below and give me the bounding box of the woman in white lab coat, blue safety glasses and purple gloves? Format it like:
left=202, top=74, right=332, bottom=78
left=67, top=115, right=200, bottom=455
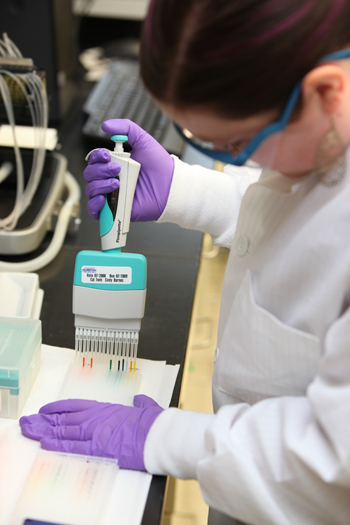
left=21, top=0, right=350, bottom=525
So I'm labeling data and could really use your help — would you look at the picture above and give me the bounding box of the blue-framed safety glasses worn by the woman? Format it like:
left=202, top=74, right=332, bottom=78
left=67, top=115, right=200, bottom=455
left=175, top=49, right=350, bottom=167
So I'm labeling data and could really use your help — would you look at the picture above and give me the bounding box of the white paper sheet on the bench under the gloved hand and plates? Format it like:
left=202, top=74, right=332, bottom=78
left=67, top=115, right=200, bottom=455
left=0, top=345, right=179, bottom=525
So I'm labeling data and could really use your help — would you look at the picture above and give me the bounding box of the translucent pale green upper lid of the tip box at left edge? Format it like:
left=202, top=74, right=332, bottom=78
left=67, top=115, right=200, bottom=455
left=0, top=317, right=41, bottom=389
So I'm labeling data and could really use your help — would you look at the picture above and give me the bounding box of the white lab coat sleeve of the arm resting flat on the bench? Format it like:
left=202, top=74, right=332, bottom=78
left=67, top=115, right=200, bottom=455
left=145, top=302, right=350, bottom=525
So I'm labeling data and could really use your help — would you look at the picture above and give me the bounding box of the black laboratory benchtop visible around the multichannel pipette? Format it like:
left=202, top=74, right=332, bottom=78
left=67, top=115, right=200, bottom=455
left=0, top=98, right=202, bottom=525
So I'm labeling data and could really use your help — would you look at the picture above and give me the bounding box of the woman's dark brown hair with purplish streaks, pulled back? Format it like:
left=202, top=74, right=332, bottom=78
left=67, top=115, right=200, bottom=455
left=141, top=0, right=350, bottom=118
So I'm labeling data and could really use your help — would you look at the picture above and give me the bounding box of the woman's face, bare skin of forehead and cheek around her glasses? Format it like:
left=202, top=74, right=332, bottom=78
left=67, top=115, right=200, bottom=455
left=159, top=99, right=330, bottom=177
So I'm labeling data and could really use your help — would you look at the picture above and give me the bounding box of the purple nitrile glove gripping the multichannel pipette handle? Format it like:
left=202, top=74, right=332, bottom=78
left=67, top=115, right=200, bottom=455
left=84, top=119, right=174, bottom=222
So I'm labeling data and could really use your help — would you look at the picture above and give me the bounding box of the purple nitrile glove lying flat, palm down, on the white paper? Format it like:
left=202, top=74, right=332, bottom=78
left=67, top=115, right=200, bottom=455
left=19, top=395, right=163, bottom=470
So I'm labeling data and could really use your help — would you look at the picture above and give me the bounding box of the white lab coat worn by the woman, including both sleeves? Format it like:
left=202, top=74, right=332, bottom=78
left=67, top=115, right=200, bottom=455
left=144, top=149, right=350, bottom=525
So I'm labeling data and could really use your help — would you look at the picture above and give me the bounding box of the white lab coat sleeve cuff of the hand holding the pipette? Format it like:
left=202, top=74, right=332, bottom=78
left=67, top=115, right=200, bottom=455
left=158, top=156, right=260, bottom=248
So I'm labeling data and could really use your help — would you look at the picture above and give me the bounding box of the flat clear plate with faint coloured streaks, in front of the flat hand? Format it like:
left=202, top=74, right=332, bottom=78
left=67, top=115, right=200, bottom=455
left=11, top=450, right=117, bottom=525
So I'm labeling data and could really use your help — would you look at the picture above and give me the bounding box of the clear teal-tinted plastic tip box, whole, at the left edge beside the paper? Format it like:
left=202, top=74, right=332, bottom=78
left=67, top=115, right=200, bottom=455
left=0, top=317, right=41, bottom=419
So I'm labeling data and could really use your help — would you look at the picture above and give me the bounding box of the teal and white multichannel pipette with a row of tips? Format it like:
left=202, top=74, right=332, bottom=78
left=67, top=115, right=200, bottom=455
left=73, top=135, right=147, bottom=370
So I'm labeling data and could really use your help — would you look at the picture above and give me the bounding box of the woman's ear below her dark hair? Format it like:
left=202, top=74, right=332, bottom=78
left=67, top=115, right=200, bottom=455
left=302, top=64, right=347, bottom=115
